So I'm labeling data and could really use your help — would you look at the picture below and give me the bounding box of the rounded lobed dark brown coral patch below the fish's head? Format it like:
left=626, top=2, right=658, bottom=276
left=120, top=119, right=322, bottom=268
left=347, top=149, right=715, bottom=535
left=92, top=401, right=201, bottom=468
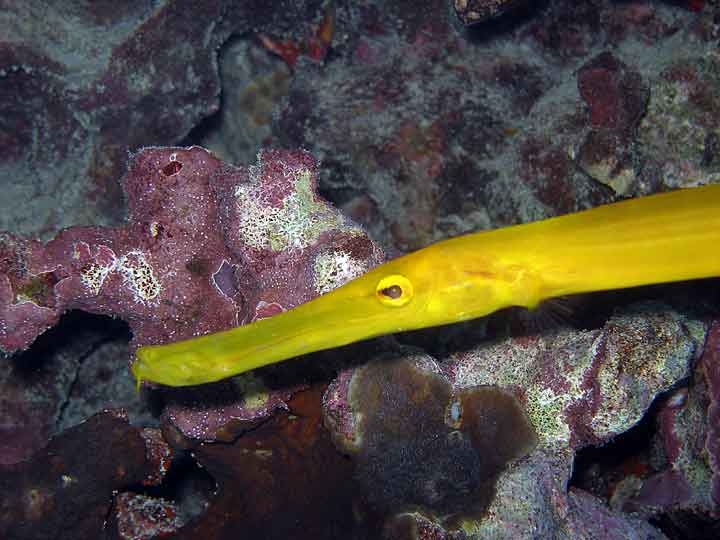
left=325, top=351, right=536, bottom=523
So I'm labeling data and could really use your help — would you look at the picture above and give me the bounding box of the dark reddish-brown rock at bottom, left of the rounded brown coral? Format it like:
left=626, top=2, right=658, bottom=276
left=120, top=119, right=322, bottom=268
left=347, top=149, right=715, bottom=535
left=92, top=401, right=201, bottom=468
left=168, top=386, right=366, bottom=540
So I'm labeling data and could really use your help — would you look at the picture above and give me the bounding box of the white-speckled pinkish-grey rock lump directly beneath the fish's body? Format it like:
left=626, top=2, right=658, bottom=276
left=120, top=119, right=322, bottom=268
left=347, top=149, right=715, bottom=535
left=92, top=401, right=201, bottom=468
left=448, top=305, right=705, bottom=448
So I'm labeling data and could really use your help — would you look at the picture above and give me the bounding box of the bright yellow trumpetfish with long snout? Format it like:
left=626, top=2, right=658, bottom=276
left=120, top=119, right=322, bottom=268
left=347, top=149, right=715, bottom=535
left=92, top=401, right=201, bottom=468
left=132, top=185, right=720, bottom=386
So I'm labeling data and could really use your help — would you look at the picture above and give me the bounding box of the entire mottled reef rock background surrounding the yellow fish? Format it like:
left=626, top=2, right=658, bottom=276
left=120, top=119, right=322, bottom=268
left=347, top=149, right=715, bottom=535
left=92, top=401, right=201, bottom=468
left=0, top=0, right=720, bottom=540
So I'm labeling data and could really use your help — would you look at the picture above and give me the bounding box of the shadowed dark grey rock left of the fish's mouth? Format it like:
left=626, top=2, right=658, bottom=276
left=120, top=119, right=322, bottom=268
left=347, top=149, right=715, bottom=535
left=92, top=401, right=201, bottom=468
left=0, top=312, right=145, bottom=464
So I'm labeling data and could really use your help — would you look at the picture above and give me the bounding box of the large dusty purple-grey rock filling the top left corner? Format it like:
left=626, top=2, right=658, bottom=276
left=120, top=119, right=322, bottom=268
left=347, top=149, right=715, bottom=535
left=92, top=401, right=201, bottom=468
left=0, top=0, right=320, bottom=237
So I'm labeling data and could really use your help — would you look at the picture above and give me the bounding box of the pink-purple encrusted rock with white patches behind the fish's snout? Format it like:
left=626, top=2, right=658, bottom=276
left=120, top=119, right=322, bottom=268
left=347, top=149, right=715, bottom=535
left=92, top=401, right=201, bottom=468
left=0, top=147, right=382, bottom=438
